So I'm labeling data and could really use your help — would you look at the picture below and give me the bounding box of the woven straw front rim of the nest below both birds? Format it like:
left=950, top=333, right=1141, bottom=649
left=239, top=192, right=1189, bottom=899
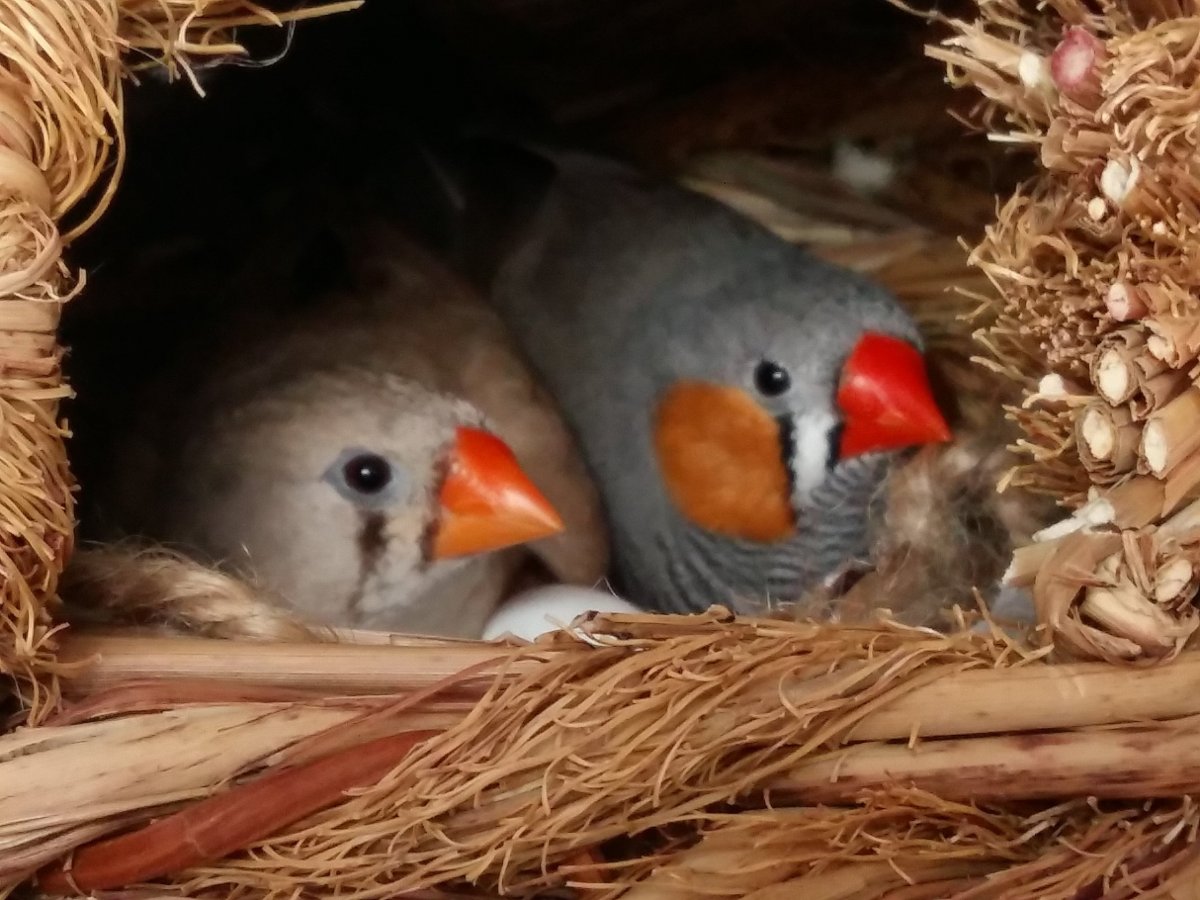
left=16, top=608, right=1200, bottom=898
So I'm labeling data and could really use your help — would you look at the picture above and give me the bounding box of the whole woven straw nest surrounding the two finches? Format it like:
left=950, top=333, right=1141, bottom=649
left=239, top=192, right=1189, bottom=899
left=0, top=0, right=1200, bottom=900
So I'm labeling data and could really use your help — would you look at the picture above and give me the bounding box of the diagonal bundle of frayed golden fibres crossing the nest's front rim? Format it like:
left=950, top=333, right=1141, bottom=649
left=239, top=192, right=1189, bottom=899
left=11, top=612, right=1010, bottom=894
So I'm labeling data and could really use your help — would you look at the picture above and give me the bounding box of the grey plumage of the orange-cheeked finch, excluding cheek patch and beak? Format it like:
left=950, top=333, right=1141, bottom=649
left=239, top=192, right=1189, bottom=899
left=468, top=154, right=919, bottom=610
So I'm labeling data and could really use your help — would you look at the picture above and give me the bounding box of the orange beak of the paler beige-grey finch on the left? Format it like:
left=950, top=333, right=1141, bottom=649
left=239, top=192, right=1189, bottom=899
left=432, top=428, right=563, bottom=559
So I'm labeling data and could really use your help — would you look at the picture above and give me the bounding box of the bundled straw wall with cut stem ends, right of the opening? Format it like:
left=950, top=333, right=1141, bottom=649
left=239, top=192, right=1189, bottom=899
left=930, top=0, right=1200, bottom=659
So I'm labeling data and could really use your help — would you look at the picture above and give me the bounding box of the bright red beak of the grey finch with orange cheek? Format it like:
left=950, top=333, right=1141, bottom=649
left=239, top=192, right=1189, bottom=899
left=838, top=332, right=950, bottom=460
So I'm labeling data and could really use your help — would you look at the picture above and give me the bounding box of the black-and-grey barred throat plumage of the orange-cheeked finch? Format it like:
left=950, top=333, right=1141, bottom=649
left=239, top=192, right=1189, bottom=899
left=618, top=454, right=890, bottom=613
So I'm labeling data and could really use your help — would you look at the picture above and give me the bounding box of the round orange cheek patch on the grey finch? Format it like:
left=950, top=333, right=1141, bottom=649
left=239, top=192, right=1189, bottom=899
left=654, top=382, right=796, bottom=541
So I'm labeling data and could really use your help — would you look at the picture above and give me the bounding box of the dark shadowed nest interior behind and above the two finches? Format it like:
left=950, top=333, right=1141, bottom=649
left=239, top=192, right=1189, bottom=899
left=62, top=0, right=1051, bottom=623
